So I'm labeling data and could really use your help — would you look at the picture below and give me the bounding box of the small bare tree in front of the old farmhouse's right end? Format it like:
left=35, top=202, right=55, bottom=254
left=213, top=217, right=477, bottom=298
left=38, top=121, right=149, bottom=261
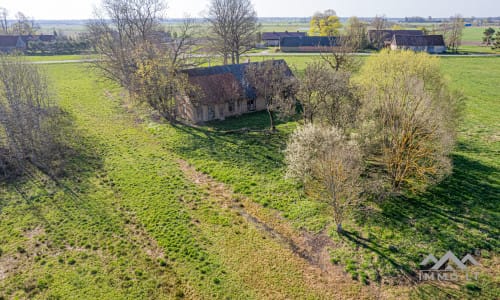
left=245, top=60, right=296, bottom=131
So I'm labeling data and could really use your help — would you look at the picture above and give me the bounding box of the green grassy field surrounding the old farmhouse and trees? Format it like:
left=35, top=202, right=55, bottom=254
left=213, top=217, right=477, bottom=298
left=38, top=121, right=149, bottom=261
left=0, top=56, right=500, bottom=299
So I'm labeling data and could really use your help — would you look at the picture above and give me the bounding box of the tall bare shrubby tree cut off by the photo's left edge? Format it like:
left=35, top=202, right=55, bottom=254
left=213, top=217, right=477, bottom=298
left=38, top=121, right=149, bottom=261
left=0, top=55, right=60, bottom=175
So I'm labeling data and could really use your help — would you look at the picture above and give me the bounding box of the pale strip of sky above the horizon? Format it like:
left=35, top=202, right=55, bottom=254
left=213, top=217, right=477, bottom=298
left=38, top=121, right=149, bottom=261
left=0, top=0, right=500, bottom=20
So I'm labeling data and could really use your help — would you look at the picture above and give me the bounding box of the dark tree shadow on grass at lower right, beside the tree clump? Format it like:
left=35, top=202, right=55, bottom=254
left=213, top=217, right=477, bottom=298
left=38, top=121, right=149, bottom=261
left=346, top=150, right=500, bottom=282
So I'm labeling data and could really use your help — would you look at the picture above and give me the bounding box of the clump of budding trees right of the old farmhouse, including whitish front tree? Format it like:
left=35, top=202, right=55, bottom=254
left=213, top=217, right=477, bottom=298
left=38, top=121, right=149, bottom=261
left=286, top=51, right=463, bottom=232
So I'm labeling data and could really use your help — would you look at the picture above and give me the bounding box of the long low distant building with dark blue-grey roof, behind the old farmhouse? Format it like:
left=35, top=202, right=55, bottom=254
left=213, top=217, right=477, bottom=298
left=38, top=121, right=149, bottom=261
left=280, top=36, right=340, bottom=52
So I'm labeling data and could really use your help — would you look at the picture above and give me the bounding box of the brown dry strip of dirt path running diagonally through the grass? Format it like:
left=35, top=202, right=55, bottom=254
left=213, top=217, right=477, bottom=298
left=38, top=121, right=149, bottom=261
left=178, top=160, right=378, bottom=299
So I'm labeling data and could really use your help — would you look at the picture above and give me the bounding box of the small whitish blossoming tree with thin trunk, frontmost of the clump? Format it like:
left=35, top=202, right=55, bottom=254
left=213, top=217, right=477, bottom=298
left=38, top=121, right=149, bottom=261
left=285, top=124, right=362, bottom=233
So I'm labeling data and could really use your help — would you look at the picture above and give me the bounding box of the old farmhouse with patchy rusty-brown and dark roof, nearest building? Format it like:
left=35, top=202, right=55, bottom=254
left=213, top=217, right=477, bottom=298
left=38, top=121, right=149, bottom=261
left=177, top=60, right=291, bottom=123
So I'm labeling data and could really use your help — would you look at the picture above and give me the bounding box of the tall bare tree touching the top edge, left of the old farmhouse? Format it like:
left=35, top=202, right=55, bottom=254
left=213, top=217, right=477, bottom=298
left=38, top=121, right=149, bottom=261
left=87, top=0, right=166, bottom=88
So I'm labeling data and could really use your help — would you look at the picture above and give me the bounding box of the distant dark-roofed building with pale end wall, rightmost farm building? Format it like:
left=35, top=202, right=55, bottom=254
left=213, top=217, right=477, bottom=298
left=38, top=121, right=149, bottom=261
left=391, top=35, right=446, bottom=54
